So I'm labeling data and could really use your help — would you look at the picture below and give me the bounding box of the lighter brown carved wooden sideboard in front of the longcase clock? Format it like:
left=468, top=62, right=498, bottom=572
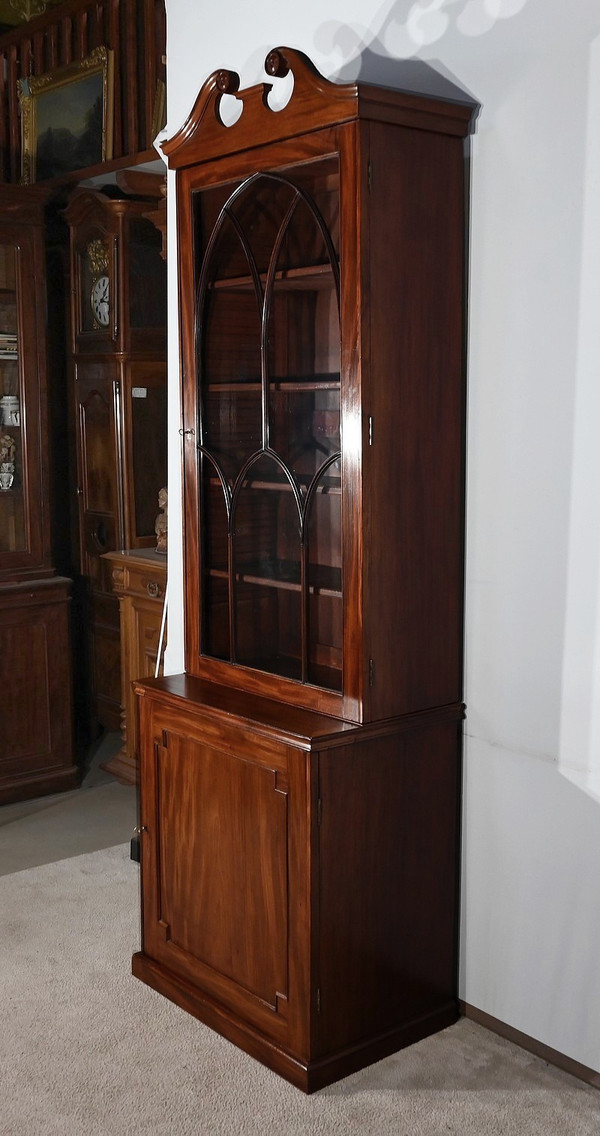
left=103, top=549, right=167, bottom=785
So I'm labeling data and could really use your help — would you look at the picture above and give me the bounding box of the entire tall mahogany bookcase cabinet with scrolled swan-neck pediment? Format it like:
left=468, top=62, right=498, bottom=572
left=133, top=49, right=473, bottom=1092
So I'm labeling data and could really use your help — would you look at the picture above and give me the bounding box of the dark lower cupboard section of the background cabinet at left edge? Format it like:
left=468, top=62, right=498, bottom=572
left=0, top=577, right=78, bottom=804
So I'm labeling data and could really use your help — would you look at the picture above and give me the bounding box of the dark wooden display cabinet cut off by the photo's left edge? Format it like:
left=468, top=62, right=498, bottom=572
left=0, top=185, right=78, bottom=804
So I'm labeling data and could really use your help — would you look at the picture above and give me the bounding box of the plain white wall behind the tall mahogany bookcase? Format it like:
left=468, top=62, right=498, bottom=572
left=161, top=0, right=600, bottom=1070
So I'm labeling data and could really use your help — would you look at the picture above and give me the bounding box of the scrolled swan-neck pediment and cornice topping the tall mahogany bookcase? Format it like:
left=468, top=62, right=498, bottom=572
left=163, top=48, right=475, bottom=168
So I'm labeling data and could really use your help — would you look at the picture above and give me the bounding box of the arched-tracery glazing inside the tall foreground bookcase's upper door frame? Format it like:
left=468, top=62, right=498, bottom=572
left=192, top=157, right=342, bottom=691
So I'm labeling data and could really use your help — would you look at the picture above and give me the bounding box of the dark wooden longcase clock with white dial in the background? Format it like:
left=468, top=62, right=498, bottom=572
left=65, top=190, right=166, bottom=729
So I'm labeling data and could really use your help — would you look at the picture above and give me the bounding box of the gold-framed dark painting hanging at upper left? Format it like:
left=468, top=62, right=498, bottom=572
left=18, top=47, right=113, bottom=185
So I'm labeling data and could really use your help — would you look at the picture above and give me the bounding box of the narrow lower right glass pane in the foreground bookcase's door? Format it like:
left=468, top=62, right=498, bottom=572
left=307, top=459, right=342, bottom=690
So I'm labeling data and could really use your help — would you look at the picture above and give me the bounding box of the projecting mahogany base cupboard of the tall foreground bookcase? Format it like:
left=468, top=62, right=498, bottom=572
left=133, top=676, right=460, bottom=1092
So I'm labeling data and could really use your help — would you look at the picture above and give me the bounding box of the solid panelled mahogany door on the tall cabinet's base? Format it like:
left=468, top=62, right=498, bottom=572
left=141, top=704, right=307, bottom=1043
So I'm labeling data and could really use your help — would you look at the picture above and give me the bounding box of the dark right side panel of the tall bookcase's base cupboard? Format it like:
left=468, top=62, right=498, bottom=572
left=319, top=724, right=459, bottom=1055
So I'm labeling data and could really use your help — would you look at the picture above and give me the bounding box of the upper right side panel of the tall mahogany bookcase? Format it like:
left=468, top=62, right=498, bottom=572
left=365, top=124, right=465, bottom=720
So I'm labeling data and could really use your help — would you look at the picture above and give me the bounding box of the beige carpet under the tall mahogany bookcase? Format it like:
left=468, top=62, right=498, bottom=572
left=0, top=846, right=600, bottom=1136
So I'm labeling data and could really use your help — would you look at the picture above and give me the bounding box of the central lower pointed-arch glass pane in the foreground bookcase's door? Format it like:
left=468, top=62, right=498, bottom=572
left=232, top=457, right=302, bottom=678
